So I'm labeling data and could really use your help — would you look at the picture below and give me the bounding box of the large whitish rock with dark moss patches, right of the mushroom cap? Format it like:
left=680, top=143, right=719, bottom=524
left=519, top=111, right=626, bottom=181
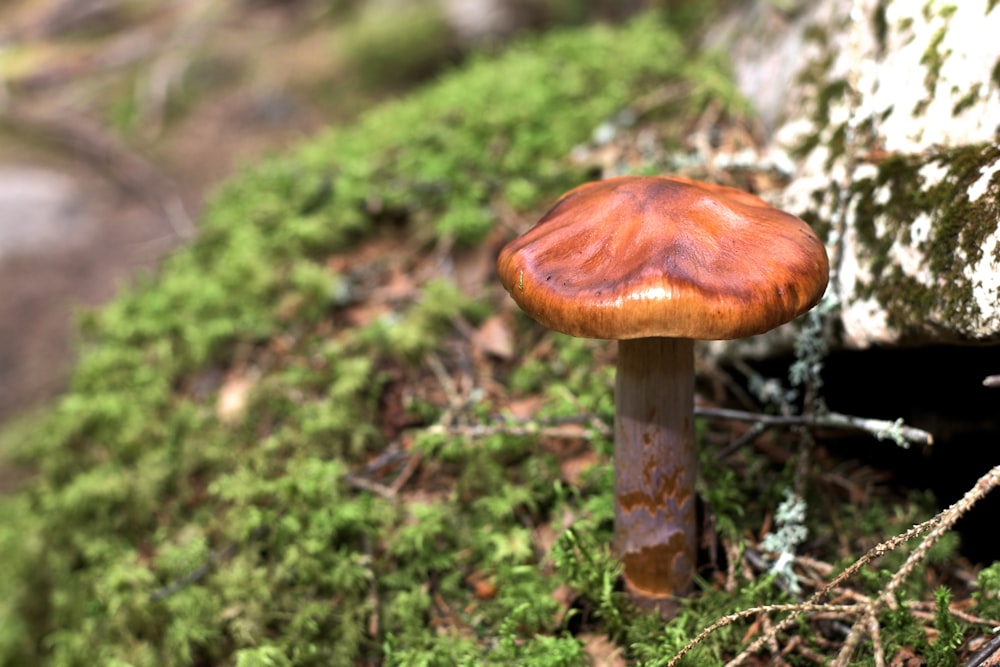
left=710, top=0, right=1000, bottom=348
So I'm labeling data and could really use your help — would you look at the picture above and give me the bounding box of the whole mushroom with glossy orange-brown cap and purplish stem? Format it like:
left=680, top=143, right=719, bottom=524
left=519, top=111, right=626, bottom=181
left=497, top=176, right=829, bottom=616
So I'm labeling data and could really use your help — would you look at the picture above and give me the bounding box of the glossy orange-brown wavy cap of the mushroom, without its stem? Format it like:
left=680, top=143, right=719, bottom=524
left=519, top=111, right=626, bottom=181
left=497, top=176, right=829, bottom=339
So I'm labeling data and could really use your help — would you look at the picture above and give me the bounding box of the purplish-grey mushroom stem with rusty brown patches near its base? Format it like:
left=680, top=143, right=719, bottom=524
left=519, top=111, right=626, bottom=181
left=614, top=338, right=698, bottom=616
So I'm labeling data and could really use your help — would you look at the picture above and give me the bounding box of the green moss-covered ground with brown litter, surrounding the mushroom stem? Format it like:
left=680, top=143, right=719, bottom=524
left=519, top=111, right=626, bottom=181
left=0, top=9, right=1000, bottom=667
